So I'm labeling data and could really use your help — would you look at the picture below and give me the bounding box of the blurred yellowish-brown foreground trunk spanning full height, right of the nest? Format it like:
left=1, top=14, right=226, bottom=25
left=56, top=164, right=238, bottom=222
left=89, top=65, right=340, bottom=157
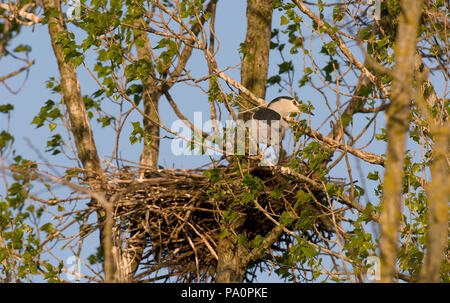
left=380, top=0, right=423, bottom=282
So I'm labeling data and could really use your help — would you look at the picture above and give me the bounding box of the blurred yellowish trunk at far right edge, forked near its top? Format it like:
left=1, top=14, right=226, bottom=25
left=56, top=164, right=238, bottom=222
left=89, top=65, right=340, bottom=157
left=415, top=54, right=450, bottom=283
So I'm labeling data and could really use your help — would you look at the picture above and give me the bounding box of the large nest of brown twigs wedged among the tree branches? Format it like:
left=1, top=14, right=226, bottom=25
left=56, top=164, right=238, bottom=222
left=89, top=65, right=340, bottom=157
left=103, top=167, right=346, bottom=282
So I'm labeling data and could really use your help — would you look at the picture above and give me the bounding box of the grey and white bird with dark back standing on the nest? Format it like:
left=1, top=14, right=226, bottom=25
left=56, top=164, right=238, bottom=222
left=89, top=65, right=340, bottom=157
left=252, top=96, right=301, bottom=165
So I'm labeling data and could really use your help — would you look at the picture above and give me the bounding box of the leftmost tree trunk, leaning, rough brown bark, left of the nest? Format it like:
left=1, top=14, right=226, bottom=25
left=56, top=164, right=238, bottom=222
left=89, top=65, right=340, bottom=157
left=42, top=0, right=123, bottom=282
